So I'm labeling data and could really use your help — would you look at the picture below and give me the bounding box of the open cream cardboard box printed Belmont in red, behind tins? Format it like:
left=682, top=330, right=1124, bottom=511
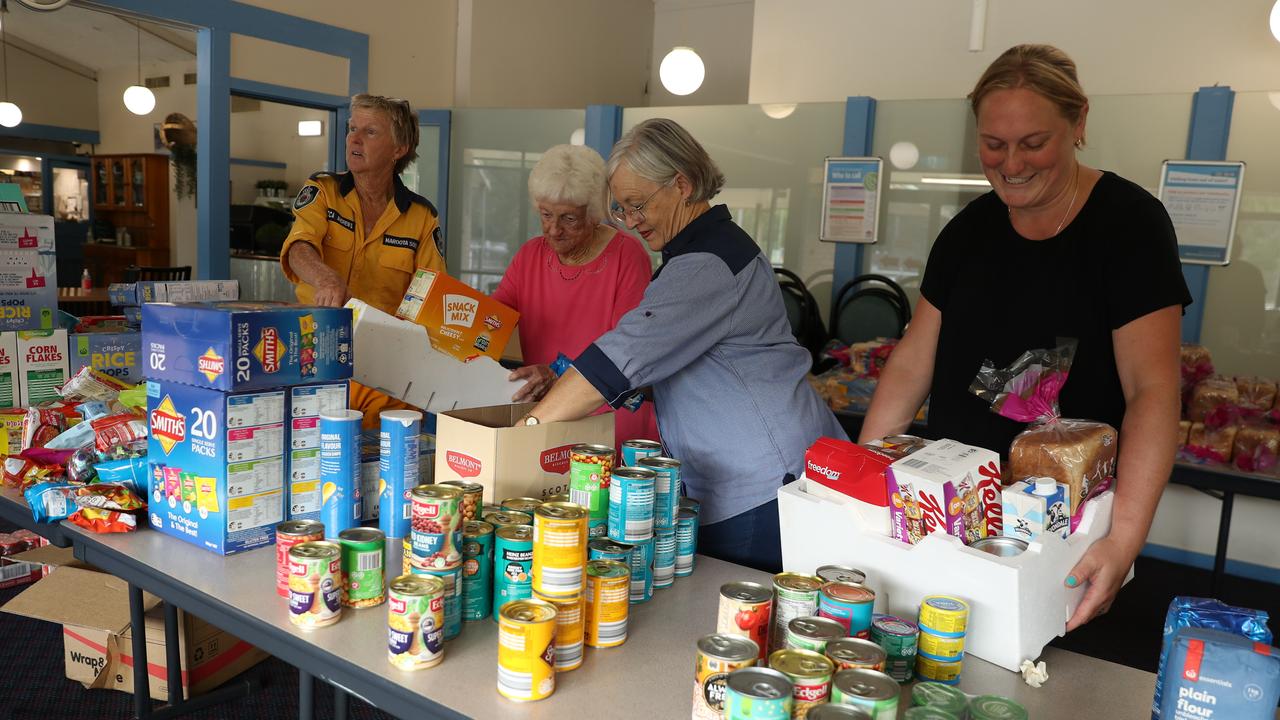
left=435, top=404, right=613, bottom=502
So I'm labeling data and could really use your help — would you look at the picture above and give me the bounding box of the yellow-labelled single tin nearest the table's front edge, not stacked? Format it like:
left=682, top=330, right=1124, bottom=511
left=498, top=600, right=557, bottom=702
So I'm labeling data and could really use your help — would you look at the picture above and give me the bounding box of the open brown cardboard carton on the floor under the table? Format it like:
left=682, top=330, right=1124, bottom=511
left=3, top=547, right=268, bottom=700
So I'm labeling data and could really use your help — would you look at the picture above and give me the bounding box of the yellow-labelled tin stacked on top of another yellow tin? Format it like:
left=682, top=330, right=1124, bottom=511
left=531, top=502, right=586, bottom=597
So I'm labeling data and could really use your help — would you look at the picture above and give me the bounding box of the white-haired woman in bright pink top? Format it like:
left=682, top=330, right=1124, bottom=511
left=493, top=145, right=658, bottom=445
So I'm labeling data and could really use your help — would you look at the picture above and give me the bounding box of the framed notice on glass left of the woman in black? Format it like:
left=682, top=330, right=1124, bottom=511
left=819, top=158, right=884, bottom=242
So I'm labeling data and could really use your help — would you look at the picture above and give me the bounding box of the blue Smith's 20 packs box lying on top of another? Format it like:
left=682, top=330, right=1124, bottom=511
left=142, top=302, right=352, bottom=392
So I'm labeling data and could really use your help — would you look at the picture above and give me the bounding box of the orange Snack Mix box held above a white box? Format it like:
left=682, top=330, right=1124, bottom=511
left=396, top=268, right=520, bottom=361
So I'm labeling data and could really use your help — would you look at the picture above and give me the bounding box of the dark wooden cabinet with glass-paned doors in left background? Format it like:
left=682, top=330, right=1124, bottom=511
left=84, top=155, right=169, bottom=284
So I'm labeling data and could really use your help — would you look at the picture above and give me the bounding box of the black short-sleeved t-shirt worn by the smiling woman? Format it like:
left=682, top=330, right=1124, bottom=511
left=920, top=173, right=1192, bottom=454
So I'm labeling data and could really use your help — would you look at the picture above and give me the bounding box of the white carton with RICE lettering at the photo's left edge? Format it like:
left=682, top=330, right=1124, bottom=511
left=0, top=213, right=58, bottom=331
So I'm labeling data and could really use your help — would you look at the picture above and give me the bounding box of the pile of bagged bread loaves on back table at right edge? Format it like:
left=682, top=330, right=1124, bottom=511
left=1178, top=345, right=1280, bottom=477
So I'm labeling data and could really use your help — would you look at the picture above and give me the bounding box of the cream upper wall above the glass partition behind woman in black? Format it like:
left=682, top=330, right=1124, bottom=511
left=749, top=0, right=1280, bottom=102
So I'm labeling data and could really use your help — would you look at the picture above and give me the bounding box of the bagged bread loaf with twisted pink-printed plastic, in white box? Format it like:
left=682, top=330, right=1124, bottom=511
left=969, top=342, right=1119, bottom=514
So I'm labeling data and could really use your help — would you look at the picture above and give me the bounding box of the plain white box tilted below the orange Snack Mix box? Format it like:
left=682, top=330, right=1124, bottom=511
left=347, top=300, right=525, bottom=413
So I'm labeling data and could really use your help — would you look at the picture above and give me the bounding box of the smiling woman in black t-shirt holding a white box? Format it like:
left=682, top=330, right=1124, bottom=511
left=860, top=45, right=1190, bottom=629
